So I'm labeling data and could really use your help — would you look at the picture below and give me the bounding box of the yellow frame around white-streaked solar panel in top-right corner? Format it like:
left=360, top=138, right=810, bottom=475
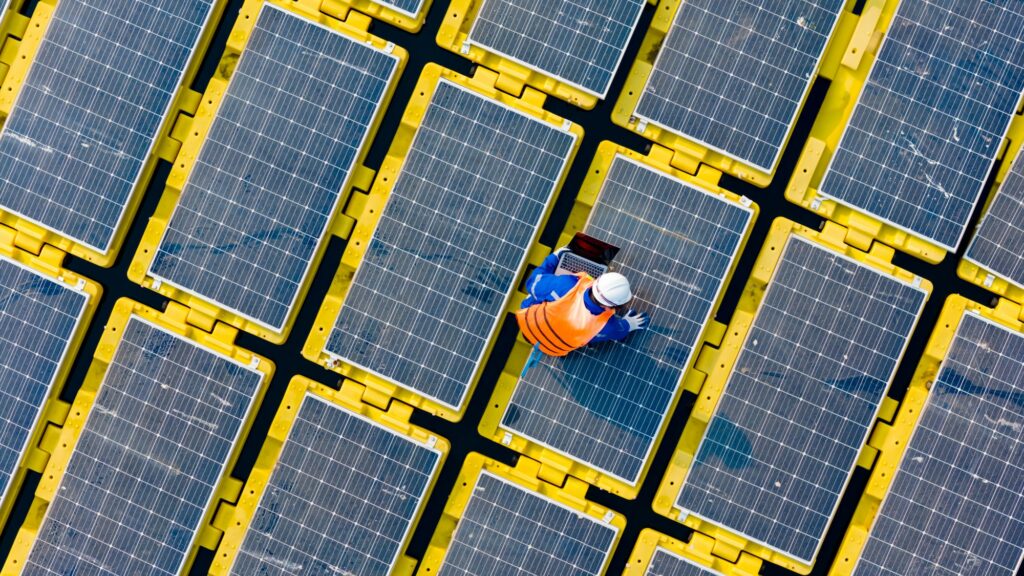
left=785, top=0, right=1024, bottom=261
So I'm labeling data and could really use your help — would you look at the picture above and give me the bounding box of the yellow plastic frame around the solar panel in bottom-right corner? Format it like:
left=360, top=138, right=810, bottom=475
left=828, top=294, right=1024, bottom=576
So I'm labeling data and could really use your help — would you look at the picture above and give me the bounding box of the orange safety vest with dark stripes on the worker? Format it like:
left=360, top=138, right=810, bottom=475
left=515, top=274, right=614, bottom=356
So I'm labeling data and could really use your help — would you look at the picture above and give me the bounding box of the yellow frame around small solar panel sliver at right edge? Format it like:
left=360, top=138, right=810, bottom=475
left=956, top=133, right=1024, bottom=304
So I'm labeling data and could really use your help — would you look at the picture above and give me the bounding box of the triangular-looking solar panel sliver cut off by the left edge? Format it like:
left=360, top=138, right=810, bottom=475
left=0, top=257, right=89, bottom=501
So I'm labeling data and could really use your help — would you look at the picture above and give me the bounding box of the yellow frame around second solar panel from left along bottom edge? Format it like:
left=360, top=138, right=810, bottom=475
left=210, top=376, right=451, bottom=576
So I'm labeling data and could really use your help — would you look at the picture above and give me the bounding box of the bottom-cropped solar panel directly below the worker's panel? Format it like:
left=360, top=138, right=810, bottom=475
left=439, top=472, right=618, bottom=576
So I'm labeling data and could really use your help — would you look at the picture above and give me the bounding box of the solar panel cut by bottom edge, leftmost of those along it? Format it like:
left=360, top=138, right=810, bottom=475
left=26, top=316, right=262, bottom=575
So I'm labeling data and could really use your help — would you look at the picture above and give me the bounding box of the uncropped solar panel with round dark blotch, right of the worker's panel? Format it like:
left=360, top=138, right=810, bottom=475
left=676, top=236, right=927, bottom=564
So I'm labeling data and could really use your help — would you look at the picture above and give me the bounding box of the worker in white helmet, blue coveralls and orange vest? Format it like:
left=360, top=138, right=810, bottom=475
left=516, top=248, right=647, bottom=356
